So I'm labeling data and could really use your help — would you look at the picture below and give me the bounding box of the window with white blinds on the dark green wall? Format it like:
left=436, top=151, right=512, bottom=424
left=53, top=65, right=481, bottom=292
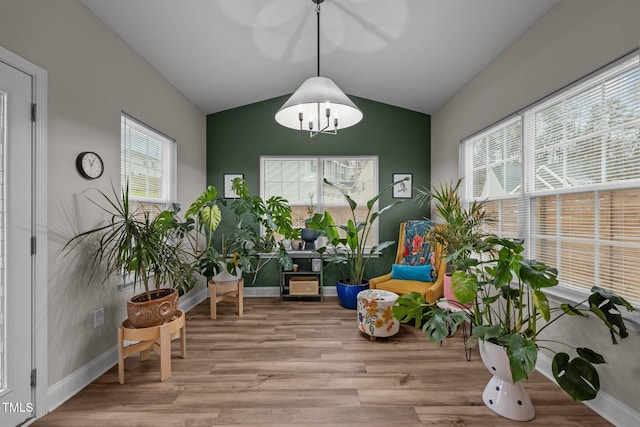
left=260, top=157, right=378, bottom=246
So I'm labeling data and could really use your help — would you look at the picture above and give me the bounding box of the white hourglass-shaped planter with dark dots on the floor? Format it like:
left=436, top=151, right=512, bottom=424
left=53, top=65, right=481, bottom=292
left=479, top=341, right=536, bottom=421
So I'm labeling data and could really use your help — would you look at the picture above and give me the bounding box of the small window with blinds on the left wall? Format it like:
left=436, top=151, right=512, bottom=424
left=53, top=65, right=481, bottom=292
left=120, top=113, right=176, bottom=204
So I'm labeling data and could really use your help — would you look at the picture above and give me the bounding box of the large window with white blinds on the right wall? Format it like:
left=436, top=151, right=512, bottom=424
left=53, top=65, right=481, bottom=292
left=461, top=53, right=640, bottom=305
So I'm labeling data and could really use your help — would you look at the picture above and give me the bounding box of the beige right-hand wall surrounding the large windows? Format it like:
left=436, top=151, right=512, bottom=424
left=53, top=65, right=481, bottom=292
left=431, top=0, right=640, bottom=422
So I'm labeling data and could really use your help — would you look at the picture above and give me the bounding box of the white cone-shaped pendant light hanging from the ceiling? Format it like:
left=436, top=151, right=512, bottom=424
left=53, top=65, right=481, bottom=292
left=275, top=0, right=362, bottom=138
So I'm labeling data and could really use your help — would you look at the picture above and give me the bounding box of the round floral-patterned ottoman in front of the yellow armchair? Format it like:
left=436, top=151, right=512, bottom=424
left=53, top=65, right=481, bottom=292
left=357, top=289, right=400, bottom=341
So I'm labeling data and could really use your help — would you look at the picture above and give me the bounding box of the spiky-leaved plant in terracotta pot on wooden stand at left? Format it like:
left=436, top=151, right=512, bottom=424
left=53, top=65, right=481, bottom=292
left=64, top=183, right=219, bottom=327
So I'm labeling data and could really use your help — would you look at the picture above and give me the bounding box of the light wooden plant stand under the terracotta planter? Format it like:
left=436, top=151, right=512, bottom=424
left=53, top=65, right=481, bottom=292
left=118, top=310, right=187, bottom=384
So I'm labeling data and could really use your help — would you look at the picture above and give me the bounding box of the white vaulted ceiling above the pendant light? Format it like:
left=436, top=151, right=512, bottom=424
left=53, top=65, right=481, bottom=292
left=83, top=0, right=558, bottom=114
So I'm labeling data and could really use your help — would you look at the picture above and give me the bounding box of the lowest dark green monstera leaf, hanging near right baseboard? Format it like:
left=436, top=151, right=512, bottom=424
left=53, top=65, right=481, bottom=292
left=551, top=353, right=600, bottom=402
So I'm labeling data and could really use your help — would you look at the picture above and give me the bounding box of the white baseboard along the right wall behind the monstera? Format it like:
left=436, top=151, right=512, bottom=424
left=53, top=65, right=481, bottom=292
left=536, top=353, right=640, bottom=427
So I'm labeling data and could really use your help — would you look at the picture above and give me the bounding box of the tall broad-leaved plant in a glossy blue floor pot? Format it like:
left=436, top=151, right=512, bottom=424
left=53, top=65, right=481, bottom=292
left=308, top=179, right=401, bottom=310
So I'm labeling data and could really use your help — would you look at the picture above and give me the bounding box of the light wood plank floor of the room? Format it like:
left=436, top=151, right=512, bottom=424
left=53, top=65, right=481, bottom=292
left=33, top=298, right=610, bottom=427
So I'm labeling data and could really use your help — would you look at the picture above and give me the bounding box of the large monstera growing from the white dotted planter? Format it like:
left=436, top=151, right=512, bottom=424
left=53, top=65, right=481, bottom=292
left=394, top=237, right=633, bottom=402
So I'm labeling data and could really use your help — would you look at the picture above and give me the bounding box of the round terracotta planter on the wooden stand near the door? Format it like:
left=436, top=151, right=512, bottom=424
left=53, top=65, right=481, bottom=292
left=127, top=288, right=178, bottom=328
